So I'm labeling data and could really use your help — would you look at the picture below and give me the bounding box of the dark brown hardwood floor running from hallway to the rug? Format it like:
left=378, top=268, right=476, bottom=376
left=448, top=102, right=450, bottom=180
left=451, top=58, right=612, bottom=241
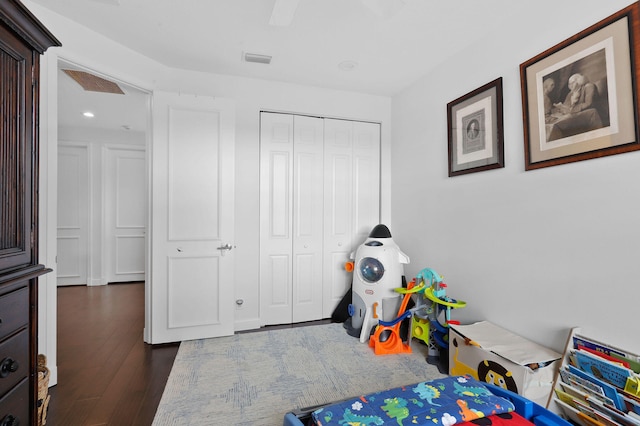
left=47, top=283, right=179, bottom=426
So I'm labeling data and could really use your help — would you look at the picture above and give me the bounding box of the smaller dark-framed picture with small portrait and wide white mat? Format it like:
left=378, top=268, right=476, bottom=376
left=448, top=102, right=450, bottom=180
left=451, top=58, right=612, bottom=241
left=447, top=77, right=504, bottom=177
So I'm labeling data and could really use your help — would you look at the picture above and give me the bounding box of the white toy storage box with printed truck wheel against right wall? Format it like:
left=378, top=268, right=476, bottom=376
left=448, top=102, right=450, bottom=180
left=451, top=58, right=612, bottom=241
left=449, top=321, right=562, bottom=407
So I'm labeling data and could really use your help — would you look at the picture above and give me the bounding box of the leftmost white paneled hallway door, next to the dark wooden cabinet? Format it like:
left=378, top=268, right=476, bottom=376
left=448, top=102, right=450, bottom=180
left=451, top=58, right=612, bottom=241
left=56, top=145, right=89, bottom=286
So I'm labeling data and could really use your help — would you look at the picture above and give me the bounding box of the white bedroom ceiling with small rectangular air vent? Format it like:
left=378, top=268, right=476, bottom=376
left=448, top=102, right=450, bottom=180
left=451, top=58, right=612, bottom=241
left=33, top=0, right=524, bottom=133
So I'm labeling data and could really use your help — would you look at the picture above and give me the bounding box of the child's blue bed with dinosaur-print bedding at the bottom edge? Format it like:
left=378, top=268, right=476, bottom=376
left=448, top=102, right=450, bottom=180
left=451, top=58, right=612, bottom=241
left=284, top=376, right=571, bottom=426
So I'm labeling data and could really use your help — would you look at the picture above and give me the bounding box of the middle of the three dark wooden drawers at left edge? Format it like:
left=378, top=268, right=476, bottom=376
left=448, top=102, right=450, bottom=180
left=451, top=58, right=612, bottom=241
left=0, top=329, right=29, bottom=398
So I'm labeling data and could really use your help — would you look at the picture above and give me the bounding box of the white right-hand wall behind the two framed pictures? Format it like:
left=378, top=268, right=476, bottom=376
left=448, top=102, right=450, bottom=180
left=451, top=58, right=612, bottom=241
left=390, top=0, right=640, bottom=353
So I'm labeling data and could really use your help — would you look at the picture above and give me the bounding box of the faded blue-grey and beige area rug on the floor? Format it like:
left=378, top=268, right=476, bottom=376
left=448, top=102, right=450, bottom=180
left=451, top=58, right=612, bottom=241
left=153, top=324, right=444, bottom=426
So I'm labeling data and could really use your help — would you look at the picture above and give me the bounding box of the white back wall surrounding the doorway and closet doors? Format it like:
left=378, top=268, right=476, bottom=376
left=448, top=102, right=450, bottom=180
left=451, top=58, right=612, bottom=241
left=24, top=0, right=391, bottom=353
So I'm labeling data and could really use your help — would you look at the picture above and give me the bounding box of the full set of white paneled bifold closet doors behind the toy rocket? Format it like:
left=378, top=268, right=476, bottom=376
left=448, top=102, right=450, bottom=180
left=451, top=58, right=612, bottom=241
left=260, top=113, right=380, bottom=324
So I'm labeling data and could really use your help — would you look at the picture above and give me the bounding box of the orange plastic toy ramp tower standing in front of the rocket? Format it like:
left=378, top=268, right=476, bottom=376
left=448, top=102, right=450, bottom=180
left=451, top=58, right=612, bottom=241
left=369, top=280, right=424, bottom=355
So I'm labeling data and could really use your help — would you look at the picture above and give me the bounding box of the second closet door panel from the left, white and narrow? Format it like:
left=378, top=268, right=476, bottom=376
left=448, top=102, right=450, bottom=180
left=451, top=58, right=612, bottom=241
left=292, top=116, right=324, bottom=322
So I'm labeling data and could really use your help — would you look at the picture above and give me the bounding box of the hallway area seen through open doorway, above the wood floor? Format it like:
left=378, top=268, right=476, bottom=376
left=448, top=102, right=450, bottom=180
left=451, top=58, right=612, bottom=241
left=57, top=59, right=150, bottom=286
